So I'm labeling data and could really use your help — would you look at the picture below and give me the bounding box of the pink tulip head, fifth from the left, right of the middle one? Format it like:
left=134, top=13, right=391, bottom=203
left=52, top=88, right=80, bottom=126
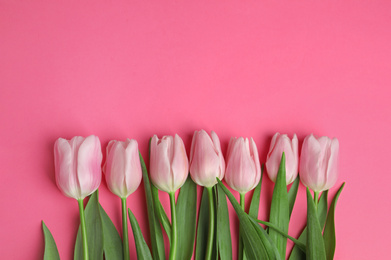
left=225, top=137, right=261, bottom=193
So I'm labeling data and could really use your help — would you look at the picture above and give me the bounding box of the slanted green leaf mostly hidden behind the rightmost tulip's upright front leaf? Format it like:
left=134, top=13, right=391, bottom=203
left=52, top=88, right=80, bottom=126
left=289, top=190, right=328, bottom=260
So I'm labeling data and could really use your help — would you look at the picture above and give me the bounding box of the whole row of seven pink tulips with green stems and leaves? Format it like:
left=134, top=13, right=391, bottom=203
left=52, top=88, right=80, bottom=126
left=43, top=130, right=343, bottom=260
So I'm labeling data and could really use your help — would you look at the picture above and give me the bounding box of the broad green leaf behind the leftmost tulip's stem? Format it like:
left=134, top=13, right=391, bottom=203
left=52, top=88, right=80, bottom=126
left=74, top=190, right=103, bottom=260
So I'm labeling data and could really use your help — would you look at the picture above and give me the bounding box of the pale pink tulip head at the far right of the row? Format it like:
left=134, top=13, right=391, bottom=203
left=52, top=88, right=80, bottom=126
left=300, top=134, right=339, bottom=192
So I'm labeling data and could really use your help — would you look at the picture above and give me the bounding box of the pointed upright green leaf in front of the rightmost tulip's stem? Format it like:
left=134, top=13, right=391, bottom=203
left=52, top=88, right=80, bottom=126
left=306, top=187, right=326, bottom=260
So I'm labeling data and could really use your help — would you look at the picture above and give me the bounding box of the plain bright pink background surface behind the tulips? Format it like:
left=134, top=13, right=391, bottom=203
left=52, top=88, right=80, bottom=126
left=0, top=0, right=391, bottom=259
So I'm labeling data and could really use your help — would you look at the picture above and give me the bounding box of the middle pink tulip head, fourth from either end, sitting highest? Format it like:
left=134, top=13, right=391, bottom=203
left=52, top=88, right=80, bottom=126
left=190, top=130, right=225, bottom=187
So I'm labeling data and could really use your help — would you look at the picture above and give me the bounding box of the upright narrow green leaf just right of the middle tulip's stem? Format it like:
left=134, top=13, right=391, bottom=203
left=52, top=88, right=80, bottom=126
left=216, top=183, right=232, bottom=260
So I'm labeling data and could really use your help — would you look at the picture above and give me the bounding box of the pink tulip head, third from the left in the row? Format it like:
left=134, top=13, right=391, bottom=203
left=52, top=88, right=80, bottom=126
left=150, top=134, right=189, bottom=193
